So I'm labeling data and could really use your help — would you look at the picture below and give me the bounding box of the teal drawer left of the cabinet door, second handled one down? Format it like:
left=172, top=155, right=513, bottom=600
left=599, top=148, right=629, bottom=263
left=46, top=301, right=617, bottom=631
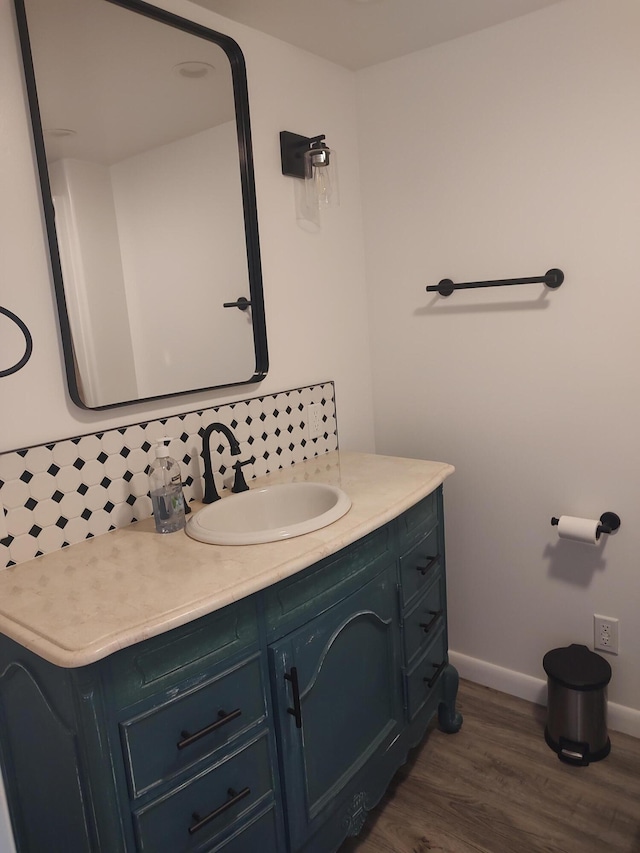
left=133, top=733, right=273, bottom=853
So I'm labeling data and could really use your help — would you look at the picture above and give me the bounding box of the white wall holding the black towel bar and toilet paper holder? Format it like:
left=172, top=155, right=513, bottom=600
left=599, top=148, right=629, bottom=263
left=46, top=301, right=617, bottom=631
left=358, top=0, right=640, bottom=720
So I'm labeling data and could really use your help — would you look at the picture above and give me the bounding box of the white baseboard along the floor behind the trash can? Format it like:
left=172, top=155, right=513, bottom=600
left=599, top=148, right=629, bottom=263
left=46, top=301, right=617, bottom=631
left=449, top=651, right=640, bottom=737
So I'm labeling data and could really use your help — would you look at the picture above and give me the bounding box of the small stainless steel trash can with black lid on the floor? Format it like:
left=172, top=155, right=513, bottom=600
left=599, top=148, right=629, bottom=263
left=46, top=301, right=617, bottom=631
left=542, top=643, right=611, bottom=765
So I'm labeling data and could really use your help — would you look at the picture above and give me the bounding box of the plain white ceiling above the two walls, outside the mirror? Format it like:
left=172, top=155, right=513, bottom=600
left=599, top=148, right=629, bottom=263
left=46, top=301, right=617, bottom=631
left=194, top=0, right=561, bottom=70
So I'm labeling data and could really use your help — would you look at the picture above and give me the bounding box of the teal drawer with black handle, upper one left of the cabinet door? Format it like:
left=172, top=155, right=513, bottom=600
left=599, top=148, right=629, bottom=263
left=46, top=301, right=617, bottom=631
left=120, top=655, right=266, bottom=797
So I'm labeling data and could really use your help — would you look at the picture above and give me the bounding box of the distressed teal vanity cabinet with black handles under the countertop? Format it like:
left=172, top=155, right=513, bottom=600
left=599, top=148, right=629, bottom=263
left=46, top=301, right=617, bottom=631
left=0, top=488, right=461, bottom=853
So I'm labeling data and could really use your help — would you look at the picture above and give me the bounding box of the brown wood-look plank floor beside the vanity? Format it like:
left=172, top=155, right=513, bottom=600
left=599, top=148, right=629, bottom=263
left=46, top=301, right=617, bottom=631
left=340, top=681, right=640, bottom=853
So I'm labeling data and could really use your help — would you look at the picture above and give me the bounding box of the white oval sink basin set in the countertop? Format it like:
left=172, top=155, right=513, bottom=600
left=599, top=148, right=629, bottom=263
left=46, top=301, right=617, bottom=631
left=186, top=483, right=351, bottom=545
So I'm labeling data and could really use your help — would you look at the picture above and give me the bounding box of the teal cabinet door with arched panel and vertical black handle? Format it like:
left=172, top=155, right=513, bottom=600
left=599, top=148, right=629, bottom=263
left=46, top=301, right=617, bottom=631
left=270, top=566, right=402, bottom=850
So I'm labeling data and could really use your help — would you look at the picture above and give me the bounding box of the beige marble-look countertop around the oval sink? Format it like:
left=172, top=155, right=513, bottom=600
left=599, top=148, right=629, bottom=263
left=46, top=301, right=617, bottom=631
left=0, top=451, right=454, bottom=667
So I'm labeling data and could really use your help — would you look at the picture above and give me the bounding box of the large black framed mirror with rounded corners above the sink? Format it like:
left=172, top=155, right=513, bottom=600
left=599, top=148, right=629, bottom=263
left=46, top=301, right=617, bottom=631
left=14, top=0, right=268, bottom=409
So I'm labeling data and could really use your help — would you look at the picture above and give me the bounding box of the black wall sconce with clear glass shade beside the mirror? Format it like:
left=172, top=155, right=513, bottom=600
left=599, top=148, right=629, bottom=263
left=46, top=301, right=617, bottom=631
left=280, top=130, right=339, bottom=225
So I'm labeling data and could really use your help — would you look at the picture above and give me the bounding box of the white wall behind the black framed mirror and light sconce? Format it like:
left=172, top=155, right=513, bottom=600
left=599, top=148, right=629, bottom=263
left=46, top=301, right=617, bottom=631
left=0, top=0, right=373, bottom=452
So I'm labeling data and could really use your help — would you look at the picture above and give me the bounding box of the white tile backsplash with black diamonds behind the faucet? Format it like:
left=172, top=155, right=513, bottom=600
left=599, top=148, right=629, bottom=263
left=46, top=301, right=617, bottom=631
left=0, top=382, right=338, bottom=568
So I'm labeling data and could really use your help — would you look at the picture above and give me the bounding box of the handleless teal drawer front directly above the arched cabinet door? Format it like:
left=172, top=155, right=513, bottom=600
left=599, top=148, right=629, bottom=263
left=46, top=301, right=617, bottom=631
left=265, top=525, right=395, bottom=635
